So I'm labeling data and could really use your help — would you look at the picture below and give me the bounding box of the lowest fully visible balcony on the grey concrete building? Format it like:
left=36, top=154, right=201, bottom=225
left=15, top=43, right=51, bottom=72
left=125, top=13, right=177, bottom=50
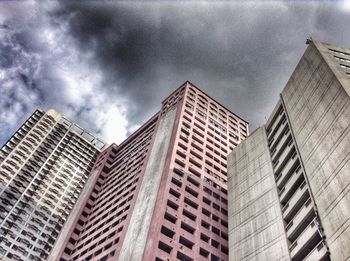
left=290, top=220, right=322, bottom=261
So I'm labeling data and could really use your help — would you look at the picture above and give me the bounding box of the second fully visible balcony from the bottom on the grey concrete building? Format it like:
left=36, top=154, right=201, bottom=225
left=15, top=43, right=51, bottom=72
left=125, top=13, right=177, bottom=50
left=286, top=199, right=315, bottom=242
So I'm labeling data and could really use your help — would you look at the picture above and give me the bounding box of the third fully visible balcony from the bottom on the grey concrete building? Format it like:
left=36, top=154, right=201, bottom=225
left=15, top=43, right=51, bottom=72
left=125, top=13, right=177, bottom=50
left=282, top=182, right=310, bottom=223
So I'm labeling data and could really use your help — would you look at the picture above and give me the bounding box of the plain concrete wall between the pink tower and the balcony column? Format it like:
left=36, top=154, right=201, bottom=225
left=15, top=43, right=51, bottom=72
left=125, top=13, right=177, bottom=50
left=228, top=127, right=289, bottom=261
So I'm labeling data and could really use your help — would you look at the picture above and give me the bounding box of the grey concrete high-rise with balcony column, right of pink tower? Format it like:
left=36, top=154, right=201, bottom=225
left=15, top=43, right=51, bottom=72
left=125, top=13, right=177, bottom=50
left=228, top=40, right=350, bottom=261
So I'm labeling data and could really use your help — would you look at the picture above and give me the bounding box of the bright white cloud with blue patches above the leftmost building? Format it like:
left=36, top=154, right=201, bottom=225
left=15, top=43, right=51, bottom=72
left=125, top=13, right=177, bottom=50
left=0, top=2, right=128, bottom=143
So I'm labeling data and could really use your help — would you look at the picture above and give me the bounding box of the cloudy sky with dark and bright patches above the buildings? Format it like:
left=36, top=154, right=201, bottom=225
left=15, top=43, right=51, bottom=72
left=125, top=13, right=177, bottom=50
left=0, top=0, right=350, bottom=146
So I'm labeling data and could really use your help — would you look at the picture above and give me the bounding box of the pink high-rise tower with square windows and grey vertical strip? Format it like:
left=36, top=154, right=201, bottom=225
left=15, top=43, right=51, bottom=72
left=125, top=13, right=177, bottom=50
left=49, top=82, right=249, bottom=261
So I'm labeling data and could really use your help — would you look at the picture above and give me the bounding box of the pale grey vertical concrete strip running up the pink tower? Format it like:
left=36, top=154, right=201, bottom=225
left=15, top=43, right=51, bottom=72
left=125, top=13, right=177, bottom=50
left=119, top=106, right=176, bottom=261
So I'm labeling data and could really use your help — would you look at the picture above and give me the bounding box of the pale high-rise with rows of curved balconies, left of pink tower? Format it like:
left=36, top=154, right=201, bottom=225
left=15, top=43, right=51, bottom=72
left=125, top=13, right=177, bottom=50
left=0, top=110, right=106, bottom=260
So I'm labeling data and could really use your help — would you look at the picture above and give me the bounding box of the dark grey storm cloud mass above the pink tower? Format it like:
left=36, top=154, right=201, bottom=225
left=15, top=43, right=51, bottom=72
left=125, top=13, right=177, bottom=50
left=51, top=2, right=350, bottom=132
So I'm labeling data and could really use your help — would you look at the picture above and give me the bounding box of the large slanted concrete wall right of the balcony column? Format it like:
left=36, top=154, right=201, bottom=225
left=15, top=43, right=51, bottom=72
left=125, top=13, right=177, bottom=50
left=282, top=43, right=350, bottom=260
